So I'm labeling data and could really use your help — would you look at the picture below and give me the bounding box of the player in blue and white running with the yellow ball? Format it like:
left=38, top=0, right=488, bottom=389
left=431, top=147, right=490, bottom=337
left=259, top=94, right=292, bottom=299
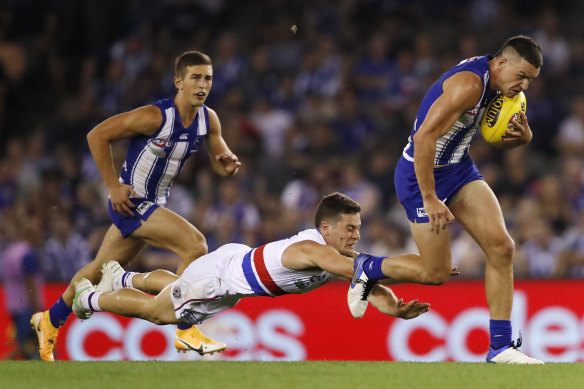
left=349, top=35, right=543, bottom=364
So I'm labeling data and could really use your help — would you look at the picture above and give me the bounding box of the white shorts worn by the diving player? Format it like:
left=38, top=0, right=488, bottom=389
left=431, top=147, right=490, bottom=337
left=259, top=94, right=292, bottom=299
left=170, top=244, right=250, bottom=324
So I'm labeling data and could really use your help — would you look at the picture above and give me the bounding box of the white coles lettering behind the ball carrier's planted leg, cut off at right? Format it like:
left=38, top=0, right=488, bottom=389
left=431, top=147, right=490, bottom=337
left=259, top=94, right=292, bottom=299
left=387, top=292, right=584, bottom=362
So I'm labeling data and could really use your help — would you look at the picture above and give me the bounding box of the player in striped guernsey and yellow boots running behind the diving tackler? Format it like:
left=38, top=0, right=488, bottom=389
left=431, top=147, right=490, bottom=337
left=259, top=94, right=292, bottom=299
left=30, top=51, right=241, bottom=361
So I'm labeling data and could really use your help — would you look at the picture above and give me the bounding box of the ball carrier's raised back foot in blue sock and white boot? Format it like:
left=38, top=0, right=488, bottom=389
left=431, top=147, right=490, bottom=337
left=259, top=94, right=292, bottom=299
left=347, top=254, right=386, bottom=319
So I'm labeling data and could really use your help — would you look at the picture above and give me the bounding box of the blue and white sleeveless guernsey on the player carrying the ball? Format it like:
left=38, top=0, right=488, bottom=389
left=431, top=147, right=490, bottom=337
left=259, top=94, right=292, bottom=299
left=403, top=55, right=497, bottom=165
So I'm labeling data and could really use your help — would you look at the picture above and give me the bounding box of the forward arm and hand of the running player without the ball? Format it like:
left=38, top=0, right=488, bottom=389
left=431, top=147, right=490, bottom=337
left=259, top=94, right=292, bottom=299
left=206, top=108, right=241, bottom=177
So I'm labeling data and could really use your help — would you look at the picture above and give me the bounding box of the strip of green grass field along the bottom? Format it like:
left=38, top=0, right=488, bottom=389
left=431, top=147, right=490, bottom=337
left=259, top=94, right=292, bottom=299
left=0, top=361, right=584, bottom=389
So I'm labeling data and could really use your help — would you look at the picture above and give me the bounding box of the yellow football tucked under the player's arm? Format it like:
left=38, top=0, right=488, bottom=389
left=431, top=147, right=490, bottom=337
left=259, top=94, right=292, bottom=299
left=481, top=92, right=527, bottom=143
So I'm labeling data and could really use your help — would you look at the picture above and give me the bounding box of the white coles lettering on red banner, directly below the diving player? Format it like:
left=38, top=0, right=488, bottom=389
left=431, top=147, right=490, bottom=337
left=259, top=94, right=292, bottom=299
left=66, top=309, right=307, bottom=361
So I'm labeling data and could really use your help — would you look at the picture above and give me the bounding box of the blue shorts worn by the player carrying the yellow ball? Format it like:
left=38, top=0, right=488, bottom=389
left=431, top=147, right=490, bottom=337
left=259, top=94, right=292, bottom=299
left=394, top=156, right=484, bottom=223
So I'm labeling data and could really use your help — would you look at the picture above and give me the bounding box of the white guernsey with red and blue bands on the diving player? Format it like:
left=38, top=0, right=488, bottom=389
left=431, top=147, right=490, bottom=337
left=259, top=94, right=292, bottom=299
left=241, top=229, right=335, bottom=297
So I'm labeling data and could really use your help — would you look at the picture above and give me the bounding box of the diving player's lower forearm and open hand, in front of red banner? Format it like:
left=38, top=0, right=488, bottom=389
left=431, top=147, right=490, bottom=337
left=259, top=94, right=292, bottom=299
left=369, top=285, right=430, bottom=320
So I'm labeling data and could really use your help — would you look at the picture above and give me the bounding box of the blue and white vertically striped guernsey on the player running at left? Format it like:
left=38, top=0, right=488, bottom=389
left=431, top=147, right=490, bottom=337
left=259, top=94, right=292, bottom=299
left=120, top=98, right=209, bottom=205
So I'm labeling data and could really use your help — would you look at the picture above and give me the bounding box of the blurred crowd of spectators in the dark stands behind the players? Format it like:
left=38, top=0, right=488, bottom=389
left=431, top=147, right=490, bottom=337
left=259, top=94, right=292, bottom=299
left=0, top=0, right=584, bottom=281
